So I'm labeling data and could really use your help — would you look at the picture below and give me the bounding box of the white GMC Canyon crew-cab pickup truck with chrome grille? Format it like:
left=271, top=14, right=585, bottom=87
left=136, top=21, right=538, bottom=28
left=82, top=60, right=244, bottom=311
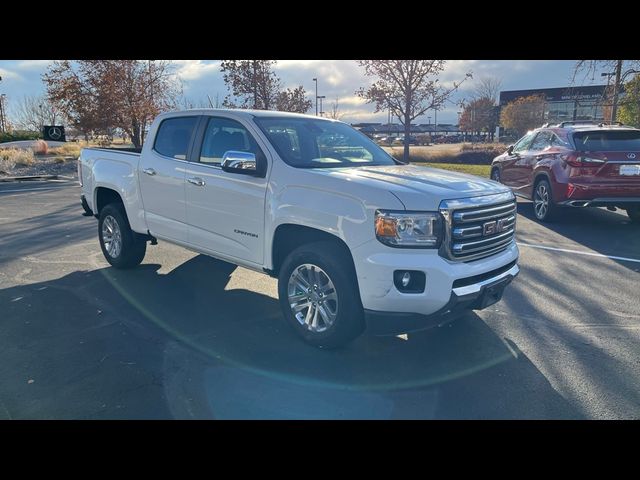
left=78, top=109, right=519, bottom=348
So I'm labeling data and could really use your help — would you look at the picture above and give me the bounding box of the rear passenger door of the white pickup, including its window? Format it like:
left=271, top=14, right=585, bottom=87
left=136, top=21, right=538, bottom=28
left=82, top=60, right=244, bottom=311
left=138, top=115, right=199, bottom=242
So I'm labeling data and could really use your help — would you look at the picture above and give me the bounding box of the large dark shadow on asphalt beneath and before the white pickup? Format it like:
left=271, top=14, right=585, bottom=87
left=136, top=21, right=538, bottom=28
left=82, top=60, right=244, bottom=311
left=0, top=255, right=581, bottom=419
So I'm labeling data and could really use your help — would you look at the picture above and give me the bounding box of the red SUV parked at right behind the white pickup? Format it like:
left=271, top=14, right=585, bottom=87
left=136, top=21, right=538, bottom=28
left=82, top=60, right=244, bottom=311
left=491, top=122, right=640, bottom=222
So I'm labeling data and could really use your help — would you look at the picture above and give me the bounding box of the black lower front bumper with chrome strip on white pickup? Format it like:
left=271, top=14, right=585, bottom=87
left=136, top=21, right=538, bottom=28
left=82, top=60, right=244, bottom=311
left=364, top=261, right=520, bottom=335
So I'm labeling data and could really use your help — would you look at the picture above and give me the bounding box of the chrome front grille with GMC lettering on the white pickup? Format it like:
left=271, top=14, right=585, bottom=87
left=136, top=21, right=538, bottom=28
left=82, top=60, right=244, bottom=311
left=440, top=192, right=517, bottom=261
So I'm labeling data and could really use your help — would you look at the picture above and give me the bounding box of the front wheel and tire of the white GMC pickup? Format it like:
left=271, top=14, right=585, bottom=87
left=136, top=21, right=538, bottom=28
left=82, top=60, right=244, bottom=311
left=278, top=241, right=364, bottom=348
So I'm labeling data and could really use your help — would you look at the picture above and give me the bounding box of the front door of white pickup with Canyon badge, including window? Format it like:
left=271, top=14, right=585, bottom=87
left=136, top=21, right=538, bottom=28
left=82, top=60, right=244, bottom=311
left=185, top=117, right=267, bottom=265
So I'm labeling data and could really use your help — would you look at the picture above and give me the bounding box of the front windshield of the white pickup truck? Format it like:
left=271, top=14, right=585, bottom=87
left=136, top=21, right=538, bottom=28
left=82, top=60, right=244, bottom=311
left=255, top=117, right=396, bottom=168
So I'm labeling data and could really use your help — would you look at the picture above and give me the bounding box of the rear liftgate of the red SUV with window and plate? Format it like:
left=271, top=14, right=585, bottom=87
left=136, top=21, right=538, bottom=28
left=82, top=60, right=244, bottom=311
left=573, top=129, right=640, bottom=193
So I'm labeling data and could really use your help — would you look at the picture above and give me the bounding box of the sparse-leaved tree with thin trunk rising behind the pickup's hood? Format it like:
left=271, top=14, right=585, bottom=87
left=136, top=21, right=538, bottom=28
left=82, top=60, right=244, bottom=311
left=356, top=60, right=471, bottom=162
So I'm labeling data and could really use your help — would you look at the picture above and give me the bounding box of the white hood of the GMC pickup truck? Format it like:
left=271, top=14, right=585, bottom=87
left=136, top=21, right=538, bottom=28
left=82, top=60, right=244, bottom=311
left=316, top=165, right=509, bottom=210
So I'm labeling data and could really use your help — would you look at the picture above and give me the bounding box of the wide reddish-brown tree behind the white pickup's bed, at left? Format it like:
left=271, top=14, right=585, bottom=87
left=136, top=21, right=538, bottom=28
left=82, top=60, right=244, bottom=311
left=43, top=60, right=182, bottom=148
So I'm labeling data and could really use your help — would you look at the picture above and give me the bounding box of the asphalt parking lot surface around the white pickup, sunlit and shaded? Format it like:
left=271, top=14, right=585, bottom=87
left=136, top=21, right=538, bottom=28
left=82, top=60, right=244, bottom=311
left=0, top=178, right=640, bottom=419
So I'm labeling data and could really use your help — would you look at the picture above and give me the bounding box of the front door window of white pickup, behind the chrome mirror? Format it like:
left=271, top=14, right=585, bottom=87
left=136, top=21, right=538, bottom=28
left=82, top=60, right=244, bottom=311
left=200, top=117, right=262, bottom=165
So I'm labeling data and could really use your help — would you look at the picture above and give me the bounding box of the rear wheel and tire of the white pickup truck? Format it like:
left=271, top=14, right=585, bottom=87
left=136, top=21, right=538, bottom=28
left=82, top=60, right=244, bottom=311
left=98, top=203, right=147, bottom=269
